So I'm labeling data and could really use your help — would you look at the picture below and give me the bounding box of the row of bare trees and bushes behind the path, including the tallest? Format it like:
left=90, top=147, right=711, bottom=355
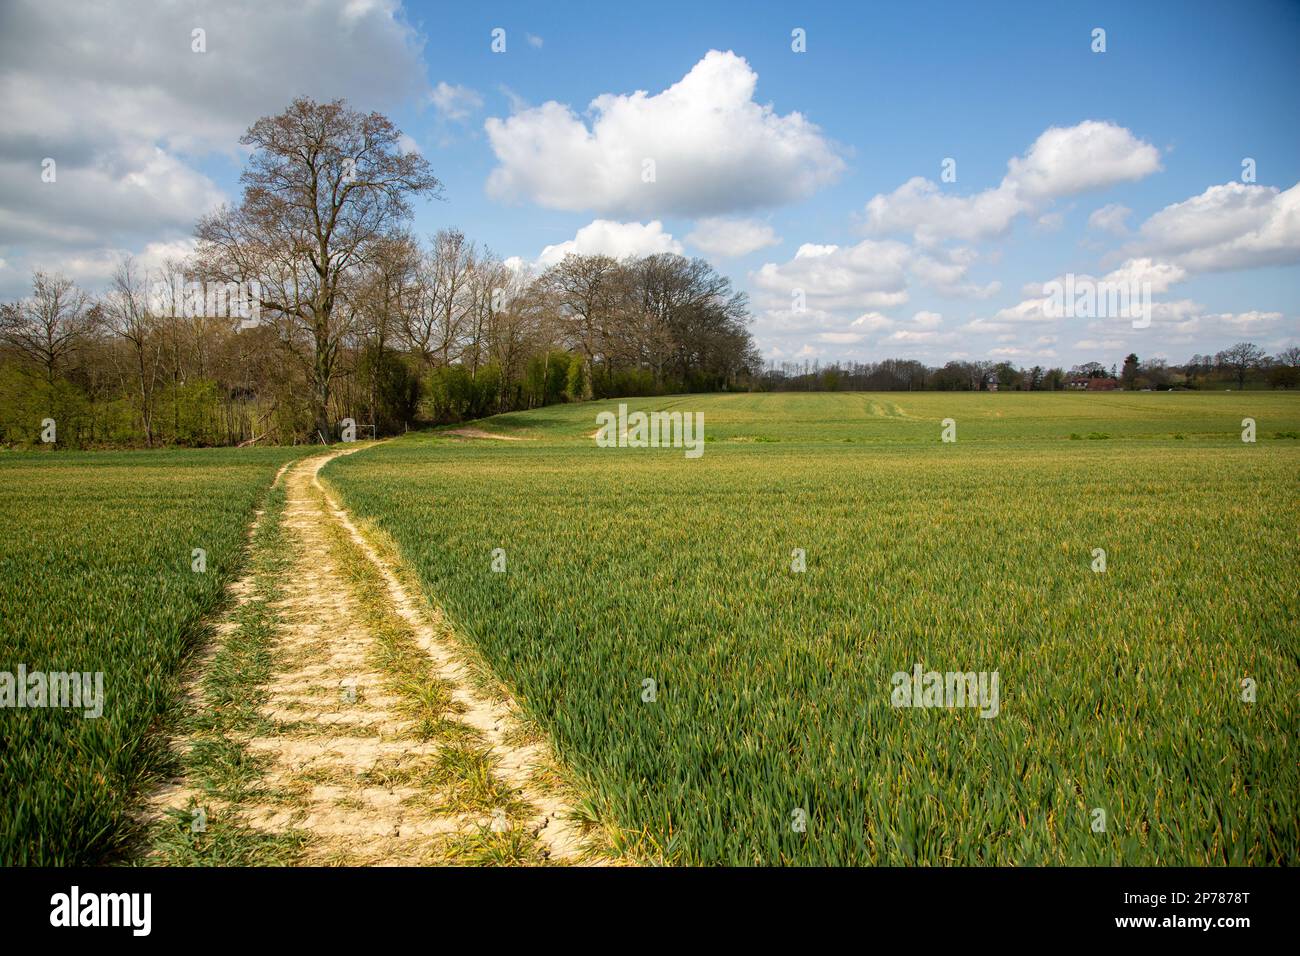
left=0, top=99, right=759, bottom=446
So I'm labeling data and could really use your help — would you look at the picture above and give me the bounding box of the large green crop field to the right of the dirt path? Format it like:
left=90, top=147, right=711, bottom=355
left=327, top=393, right=1300, bottom=865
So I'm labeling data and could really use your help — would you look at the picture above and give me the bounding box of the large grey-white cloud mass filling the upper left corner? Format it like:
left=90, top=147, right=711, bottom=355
left=0, top=0, right=426, bottom=297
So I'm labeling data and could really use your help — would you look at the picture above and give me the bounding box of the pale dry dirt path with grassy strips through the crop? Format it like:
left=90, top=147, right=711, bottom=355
left=144, top=449, right=585, bottom=865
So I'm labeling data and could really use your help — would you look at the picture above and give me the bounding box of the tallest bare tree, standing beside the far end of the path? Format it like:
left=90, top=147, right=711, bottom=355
left=196, top=98, right=442, bottom=437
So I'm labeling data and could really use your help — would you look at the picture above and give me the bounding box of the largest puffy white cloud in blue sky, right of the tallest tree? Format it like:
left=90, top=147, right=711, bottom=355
left=485, top=49, right=844, bottom=217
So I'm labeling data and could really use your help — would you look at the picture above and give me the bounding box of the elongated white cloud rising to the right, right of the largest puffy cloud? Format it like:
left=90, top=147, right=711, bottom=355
left=866, top=120, right=1160, bottom=245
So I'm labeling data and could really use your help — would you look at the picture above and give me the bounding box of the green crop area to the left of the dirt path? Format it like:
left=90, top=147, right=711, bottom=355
left=0, top=449, right=300, bottom=865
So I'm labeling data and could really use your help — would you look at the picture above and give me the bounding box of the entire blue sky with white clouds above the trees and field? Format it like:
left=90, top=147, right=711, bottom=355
left=0, top=0, right=1300, bottom=367
